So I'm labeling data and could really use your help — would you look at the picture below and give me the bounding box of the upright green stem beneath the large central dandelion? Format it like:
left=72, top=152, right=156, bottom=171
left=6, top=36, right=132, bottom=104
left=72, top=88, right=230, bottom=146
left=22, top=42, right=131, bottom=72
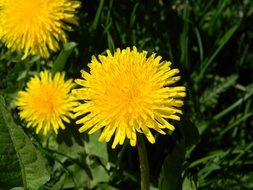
left=137, top=134, right=149, bottom=190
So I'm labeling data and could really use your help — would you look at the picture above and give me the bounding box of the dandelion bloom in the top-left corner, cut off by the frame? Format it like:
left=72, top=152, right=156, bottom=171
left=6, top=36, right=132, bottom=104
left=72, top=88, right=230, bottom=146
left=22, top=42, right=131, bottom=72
left=0, top=0, right=80, bottom=58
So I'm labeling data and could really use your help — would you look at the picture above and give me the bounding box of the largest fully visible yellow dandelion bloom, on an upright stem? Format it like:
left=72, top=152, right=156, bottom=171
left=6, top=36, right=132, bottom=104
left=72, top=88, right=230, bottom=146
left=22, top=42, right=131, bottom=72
left=72, top=47, right=186, bottom=148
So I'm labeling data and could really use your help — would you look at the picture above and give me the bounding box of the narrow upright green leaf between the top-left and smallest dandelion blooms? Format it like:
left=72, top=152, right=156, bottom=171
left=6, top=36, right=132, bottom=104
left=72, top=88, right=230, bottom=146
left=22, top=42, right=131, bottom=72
left=51, top=42, right=77, bottom=74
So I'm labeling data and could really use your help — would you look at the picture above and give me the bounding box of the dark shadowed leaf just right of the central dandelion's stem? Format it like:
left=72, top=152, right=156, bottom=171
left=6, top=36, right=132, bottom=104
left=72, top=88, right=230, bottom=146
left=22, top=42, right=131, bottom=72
left=159, top=144, right=185, bottom=190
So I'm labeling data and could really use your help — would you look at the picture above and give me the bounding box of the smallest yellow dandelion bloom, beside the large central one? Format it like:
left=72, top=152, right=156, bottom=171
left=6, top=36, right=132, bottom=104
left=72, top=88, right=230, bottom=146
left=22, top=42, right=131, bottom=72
left=16, top=71, right=76, bottom=135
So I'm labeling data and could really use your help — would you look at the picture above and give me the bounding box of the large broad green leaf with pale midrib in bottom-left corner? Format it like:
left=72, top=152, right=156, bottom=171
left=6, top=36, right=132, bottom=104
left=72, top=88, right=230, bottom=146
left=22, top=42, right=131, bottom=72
left=0, top=96, right=49, bottom=190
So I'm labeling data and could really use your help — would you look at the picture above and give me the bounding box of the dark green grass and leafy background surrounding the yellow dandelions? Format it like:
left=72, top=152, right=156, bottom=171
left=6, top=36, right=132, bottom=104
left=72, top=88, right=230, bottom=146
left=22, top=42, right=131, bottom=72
left=0, top=0, right=253, bottom=190
